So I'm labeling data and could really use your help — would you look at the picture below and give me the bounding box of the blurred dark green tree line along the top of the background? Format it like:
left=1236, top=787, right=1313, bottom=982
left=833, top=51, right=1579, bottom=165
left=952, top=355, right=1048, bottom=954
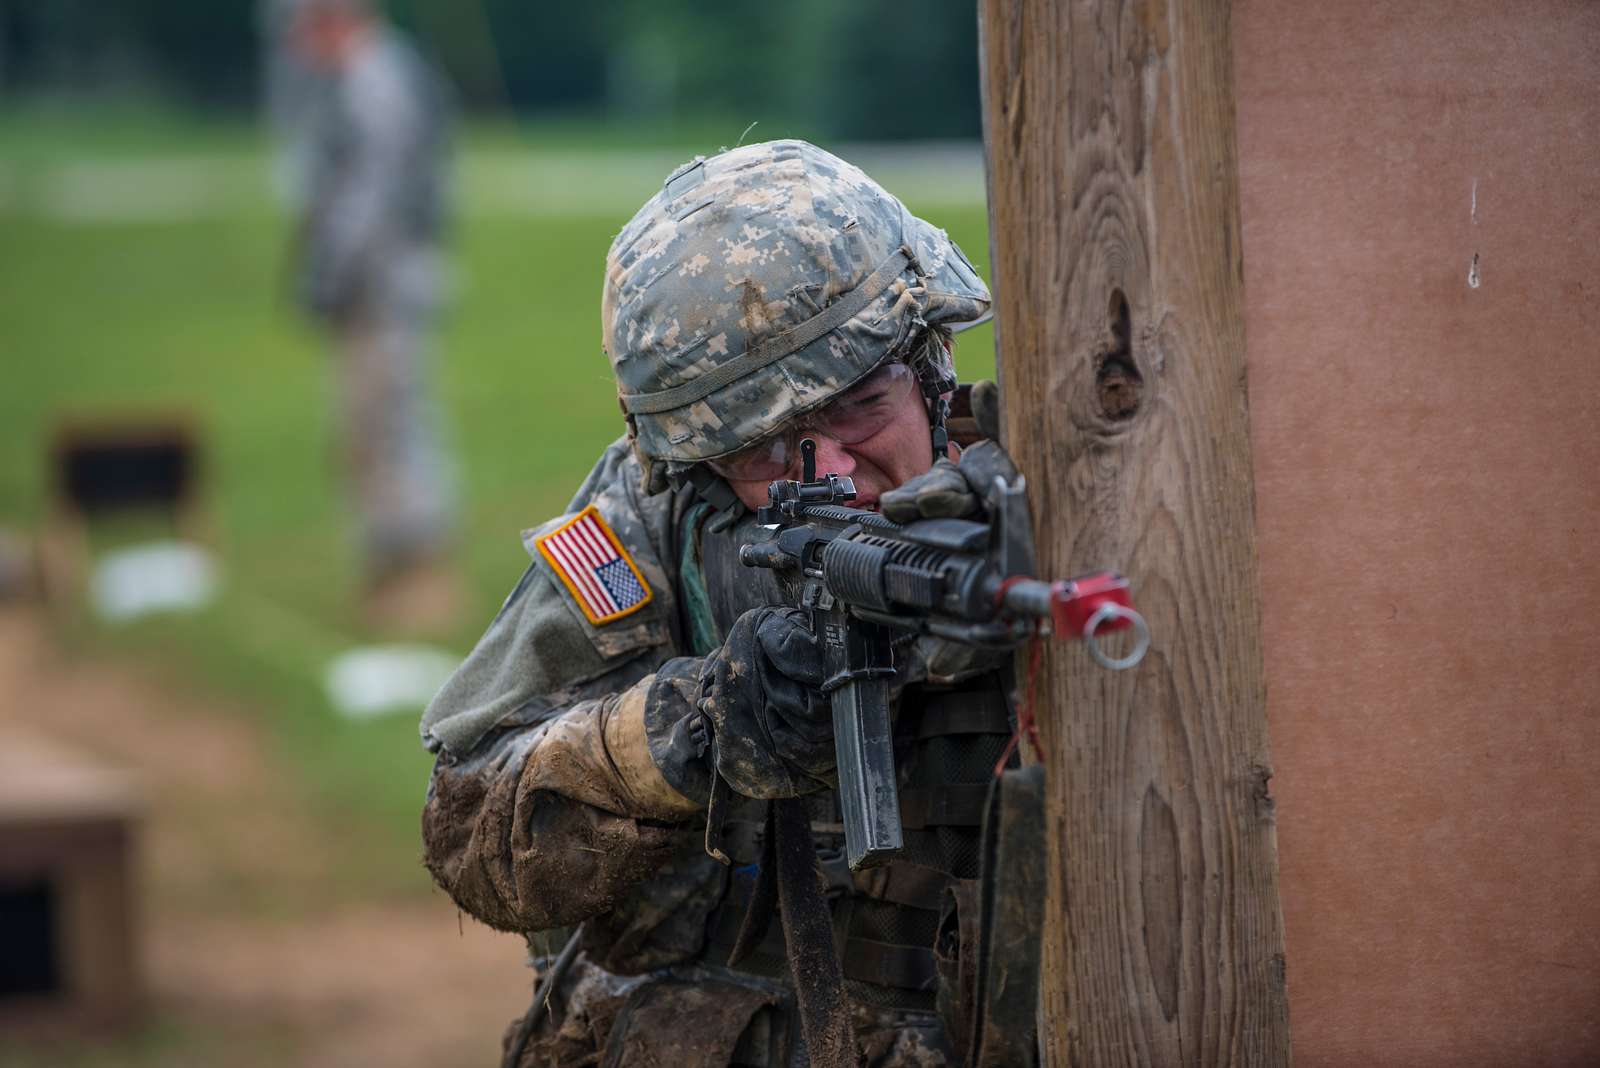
left=0, top=0, right=979, bottom=139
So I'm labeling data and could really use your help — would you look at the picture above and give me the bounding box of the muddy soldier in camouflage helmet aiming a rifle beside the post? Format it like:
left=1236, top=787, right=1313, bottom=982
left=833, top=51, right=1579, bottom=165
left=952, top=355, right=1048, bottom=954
left=422, top=141, right=1029, bottom=1068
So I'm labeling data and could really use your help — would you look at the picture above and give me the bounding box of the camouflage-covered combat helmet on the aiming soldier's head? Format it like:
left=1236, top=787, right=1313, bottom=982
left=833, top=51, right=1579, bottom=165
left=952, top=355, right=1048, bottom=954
left=600, top=141, right=989, bottom=492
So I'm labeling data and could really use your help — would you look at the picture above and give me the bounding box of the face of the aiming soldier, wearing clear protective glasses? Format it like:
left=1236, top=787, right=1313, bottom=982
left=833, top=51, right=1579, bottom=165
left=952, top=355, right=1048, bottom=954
left=714, top=365, right=933, bottom=508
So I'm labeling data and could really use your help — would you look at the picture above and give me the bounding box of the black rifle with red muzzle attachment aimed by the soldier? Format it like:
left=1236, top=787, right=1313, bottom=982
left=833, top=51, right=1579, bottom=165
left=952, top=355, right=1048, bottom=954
left=739, top=438, right=1149, bottom=870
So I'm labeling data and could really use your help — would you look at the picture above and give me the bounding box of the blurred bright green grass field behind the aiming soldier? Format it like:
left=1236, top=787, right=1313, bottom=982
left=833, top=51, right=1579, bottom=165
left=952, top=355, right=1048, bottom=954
left=0, top=112, right=994, bottom=894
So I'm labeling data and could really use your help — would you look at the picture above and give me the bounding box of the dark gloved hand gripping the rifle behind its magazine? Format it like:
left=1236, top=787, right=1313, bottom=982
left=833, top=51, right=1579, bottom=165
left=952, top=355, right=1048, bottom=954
left=699, top=608, right=835, bottom=798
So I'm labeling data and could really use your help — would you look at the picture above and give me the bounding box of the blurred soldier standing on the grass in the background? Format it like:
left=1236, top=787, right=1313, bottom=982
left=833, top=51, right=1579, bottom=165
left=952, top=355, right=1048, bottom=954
left=267, top=0, right=458, bottom=630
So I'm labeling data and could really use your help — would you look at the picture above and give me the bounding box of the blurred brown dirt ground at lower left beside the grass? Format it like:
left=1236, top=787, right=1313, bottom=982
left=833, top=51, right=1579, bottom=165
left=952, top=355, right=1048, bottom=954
left=0, top=609, right=528, bottom=1068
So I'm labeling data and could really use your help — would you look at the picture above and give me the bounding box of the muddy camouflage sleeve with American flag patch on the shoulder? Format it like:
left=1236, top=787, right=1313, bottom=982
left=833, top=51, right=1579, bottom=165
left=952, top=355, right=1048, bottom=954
left=422, top=446, right=704, bottom=931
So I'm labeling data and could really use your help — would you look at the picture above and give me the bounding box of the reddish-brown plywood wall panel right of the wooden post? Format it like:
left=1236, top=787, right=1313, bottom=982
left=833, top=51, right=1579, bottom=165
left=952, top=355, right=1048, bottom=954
left=1234, top=0, right=1600, bottom=1068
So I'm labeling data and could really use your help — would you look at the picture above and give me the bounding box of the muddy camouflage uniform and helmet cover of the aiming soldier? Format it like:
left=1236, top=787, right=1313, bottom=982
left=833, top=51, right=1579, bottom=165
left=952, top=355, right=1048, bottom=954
left=422, top=142, right=1010, bottom=1068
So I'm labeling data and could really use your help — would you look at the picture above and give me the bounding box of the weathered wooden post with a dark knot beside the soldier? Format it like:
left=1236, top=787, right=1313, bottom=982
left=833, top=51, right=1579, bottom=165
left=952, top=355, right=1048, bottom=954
left=979, top=0, right=1290, bottom=1065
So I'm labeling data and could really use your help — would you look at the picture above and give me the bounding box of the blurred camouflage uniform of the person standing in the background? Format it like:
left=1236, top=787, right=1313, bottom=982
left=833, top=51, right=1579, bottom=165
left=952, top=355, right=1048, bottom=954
left=291, top=16, right=453, bottom=576
